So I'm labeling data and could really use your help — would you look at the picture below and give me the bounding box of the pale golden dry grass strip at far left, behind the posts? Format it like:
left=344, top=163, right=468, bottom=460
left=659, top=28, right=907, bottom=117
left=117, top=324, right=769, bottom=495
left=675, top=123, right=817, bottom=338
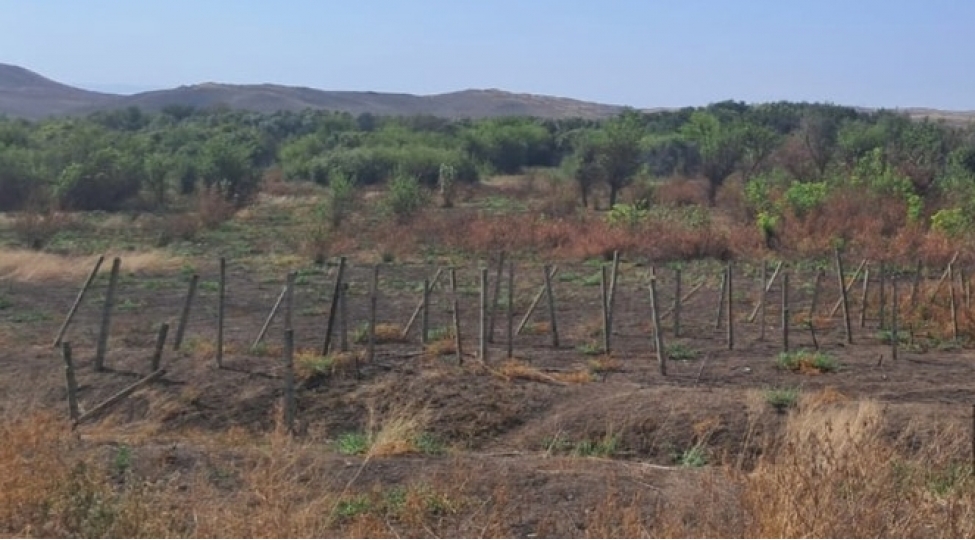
left=0, top=249, right=183, bottom=282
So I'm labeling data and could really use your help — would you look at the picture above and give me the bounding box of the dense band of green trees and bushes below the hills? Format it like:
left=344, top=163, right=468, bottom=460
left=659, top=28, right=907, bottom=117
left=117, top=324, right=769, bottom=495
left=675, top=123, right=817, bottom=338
left=0, top=101, right=975, bottom=232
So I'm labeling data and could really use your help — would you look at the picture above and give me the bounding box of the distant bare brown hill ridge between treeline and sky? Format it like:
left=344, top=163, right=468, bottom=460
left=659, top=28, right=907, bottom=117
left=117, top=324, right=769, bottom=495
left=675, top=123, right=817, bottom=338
left=0, top=63, right=975, bottom=124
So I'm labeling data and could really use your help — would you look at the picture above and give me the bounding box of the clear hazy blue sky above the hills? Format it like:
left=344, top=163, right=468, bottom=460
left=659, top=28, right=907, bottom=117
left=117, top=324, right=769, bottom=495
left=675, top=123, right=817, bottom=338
left=0, top=0, right=975, bottom=110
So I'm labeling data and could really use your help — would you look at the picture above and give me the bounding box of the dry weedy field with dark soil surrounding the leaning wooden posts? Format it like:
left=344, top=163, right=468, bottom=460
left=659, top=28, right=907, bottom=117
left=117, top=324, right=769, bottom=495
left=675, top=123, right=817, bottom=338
left=0, top=178, right=975, bottom=537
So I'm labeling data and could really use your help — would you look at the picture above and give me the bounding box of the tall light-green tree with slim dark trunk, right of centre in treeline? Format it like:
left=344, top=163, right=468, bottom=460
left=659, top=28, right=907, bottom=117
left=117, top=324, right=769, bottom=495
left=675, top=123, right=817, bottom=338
left=681, top=111, right=744, bottom=206
